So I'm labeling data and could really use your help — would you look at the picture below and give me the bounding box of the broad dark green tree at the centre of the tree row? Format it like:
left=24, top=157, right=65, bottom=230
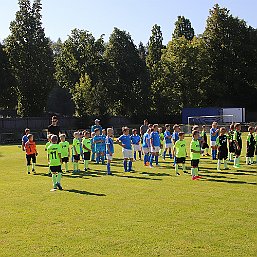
left=105, top=28, right=150, bottom=118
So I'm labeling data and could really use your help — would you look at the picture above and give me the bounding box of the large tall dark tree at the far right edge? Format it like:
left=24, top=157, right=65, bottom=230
left=203, top=5, right=256, bottom=108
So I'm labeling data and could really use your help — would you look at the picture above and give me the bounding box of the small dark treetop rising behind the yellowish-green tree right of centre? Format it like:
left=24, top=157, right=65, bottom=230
left=172, top=16, right=195, bottom=40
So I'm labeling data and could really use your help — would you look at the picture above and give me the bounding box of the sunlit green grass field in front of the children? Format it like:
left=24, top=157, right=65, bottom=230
left=0, top=135, right=257, bottom=256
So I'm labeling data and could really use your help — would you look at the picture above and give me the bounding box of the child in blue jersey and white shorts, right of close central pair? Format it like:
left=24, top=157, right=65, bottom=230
left=150, top=124, right=161, bottom=168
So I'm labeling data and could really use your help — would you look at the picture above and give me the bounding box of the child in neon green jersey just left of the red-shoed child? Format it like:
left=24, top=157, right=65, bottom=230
left=174, top=132, right=187, bottom=176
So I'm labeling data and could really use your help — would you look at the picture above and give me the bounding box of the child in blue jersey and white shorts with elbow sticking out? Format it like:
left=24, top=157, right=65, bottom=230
left=117, top=127, right=133, bottom=172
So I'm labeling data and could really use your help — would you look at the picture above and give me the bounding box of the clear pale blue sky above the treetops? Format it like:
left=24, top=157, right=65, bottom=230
left=0, top=0, right=257, bottom=44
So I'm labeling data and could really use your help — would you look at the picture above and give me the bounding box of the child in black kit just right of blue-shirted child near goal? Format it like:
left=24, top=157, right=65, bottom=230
left=216, top=127, right=228, bottom=171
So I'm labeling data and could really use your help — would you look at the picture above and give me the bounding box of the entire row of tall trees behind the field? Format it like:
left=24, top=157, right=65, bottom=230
left=0, top=0, right=257, bottom=121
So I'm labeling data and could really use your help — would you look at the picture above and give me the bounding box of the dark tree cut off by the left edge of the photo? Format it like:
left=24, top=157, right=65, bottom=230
left=0, top=44, right=17, bottom=110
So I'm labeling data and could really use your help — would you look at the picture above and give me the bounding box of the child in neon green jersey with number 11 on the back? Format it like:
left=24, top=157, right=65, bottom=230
left=47, top=135, right=62, bottom=191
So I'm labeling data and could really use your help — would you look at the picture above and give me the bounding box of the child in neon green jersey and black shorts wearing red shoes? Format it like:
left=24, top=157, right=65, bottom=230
left=190, top=130, right=202, bottom=180
